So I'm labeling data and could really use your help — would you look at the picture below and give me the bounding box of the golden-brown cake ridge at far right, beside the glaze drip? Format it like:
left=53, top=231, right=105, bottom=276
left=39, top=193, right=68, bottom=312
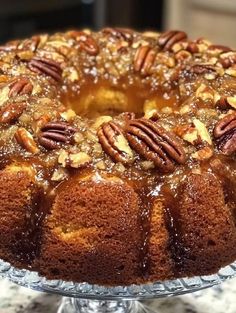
left=171, top=173, right=236, bottom=276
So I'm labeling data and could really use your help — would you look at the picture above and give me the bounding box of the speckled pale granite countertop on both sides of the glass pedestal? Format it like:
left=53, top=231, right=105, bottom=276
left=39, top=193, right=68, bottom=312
left=0, top=279, right=236, bottom=313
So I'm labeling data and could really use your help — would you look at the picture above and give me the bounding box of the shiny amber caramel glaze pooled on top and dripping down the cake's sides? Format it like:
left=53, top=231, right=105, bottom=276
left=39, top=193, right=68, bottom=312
left=0, top=28, right=236, bottom=284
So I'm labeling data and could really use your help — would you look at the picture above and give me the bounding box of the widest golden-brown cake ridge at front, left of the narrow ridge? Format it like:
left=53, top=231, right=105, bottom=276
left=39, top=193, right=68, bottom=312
left=36, top=179, right=142, bottom=284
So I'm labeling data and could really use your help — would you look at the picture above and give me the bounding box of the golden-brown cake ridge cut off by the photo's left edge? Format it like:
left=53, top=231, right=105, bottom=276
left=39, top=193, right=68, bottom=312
left=0, top=166, right=38, bottom=267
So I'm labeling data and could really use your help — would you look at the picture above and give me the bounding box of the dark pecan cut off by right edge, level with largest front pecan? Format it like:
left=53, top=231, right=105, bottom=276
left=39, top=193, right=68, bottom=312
left=214, top=112, right=236, bottom=155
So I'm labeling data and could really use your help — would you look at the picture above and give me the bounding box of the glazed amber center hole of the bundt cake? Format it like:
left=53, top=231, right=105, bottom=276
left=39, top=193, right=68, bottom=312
left=66, top=81, right=177, bottom=119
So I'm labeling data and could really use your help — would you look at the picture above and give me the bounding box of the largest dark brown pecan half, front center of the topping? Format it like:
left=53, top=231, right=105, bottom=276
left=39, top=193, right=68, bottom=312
left=125, top=118, right=186, bottom=172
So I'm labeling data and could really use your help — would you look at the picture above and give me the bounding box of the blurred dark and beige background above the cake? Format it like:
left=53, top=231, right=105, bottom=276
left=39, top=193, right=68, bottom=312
left=0, top=0, right=236, bottom=47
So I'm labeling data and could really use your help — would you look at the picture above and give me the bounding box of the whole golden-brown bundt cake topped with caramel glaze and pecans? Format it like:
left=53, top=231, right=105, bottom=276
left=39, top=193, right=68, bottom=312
left=0, top=28, right=236, bottom=286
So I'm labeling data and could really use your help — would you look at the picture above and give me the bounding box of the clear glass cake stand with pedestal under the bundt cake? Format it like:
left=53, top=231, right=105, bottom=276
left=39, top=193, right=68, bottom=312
left=0, top=260, right=236, bottom=313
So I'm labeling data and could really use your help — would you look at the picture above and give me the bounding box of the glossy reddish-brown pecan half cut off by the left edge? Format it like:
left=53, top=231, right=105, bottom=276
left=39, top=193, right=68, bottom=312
left=0, top=102, right=26, bottom=123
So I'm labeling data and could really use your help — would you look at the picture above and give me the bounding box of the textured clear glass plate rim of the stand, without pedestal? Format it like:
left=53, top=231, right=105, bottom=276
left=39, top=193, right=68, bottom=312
left=0, top=259, right=236, bottom=300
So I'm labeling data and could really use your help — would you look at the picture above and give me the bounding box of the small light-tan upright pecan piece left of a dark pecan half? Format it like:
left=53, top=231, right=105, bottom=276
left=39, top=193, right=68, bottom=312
left=15, top=127, right=39, bottom=154
